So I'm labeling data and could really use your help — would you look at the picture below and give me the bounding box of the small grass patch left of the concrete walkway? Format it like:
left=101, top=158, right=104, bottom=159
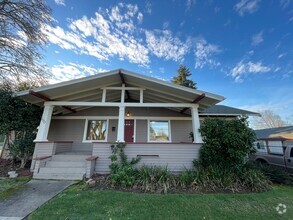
left=0, top=177, right=31, bottom=200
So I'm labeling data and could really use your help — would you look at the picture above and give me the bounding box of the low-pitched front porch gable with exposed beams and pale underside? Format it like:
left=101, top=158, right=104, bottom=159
left=16, top=69, right=224, bottom=113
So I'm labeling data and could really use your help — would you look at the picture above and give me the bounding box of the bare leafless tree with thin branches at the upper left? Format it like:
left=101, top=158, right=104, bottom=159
left=0, top=0, right=52, bottom=83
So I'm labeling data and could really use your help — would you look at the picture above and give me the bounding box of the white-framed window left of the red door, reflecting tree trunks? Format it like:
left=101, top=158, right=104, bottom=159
left=85, top=120, right=107, bottom=141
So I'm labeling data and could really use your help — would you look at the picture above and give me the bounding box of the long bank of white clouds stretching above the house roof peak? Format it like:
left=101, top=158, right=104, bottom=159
left=42, top=3, right=220, bottom=68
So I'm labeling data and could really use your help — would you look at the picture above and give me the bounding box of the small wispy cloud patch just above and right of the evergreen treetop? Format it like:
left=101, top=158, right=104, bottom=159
left=194, top=38, right=221, bottom=68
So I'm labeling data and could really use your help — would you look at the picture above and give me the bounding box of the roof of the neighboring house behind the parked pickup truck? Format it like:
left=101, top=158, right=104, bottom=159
left=255, top=126, right=293, bottom=139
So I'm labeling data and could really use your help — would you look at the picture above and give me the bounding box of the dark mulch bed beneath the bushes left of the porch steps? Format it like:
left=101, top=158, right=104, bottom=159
left=0, top=158, right=32, bottom=177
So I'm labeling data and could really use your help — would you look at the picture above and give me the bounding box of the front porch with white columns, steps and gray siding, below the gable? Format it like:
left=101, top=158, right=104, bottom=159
left=31, top=101, right=202, bottom=179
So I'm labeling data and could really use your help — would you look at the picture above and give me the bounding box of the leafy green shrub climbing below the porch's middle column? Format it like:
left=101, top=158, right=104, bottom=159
left=109, top=143, right=140, bottom=187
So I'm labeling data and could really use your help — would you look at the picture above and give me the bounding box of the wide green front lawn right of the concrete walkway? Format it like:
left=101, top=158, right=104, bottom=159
left=29, top=185, right=293, bottom=220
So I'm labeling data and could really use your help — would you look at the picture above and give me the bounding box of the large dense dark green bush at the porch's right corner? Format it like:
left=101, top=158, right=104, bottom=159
left=199, top=117, right=255, bottom=170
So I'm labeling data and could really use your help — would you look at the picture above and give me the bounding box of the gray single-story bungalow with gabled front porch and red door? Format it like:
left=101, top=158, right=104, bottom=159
left=17, top=70, right=257, bottom=179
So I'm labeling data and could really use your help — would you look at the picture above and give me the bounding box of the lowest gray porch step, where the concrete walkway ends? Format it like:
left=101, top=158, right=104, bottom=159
left=33, top=173, right=85, bottom=180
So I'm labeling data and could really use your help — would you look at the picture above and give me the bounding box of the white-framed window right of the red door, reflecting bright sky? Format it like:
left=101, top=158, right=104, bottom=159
left=149, top=121, right=171, bottom=142
